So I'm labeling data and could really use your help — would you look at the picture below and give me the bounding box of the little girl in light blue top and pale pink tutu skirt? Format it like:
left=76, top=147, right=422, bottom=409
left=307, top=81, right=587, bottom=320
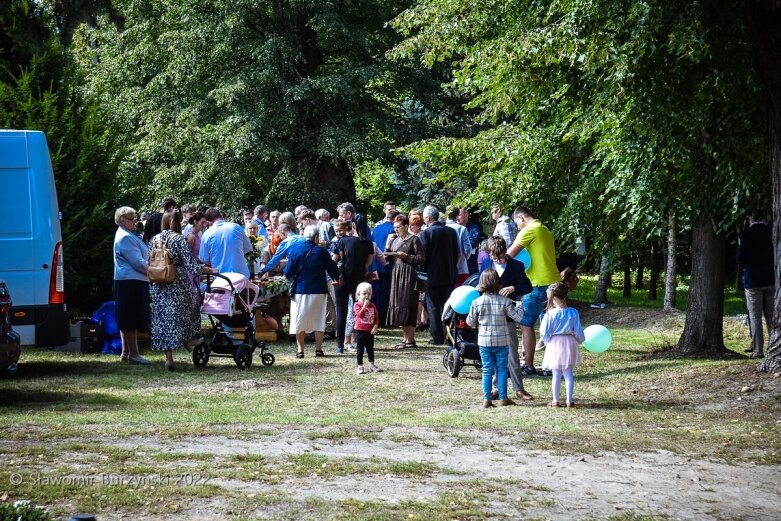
left=540, top=282, right=585, bottom=407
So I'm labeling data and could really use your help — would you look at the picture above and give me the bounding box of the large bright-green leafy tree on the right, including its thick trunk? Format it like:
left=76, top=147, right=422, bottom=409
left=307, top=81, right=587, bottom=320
left=396, top=0, right=766, bottom=353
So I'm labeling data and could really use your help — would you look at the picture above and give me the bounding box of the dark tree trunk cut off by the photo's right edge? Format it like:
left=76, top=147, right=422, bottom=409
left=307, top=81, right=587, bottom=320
left=749, top=1, right=781, bottom=372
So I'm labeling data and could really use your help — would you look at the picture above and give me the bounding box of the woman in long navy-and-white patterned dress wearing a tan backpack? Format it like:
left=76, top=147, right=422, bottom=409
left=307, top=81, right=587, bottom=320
left=149, top=211, right=215, bottom=371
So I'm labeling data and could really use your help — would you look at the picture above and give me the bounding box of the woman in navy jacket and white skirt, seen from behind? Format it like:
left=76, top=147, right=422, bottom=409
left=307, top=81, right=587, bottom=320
left=285, top=224, right=339, bottom=358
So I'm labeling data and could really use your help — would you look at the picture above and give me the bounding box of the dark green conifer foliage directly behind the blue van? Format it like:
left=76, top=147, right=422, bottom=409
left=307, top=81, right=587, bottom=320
left=0, top=5, right=117, bottom=313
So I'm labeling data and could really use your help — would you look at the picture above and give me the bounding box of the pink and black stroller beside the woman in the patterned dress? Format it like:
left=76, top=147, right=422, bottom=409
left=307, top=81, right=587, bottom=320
left=193, top=273, right=275, bottom=369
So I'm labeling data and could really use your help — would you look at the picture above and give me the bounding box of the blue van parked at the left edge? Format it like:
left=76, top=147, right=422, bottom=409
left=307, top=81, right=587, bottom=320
left=0, top=130, right=70, bottom=347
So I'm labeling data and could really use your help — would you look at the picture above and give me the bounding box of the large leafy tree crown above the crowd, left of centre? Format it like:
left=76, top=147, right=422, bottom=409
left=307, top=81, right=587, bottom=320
left=80, top=0, right=450, bottom=210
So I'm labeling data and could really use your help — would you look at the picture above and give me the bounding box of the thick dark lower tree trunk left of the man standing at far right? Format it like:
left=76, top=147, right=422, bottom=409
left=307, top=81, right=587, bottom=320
left=678, top=215, right=726, bottom=355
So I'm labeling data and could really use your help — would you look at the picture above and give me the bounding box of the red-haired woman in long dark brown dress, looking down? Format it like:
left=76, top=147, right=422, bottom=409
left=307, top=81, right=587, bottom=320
left=385, top=214, right=426, bottom=348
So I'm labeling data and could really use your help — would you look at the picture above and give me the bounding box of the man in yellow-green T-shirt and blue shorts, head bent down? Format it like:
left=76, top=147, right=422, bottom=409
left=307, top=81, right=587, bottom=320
left=507, top=206, right=561, bottom=376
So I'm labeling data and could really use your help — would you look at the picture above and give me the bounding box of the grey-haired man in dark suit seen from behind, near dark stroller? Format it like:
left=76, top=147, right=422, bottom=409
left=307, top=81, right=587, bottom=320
left=420, top=206, right=459, bottom=346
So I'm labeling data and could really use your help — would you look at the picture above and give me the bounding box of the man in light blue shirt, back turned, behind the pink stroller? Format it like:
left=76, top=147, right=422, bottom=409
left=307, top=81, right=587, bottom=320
left=198, top=208, right=252, bottom=278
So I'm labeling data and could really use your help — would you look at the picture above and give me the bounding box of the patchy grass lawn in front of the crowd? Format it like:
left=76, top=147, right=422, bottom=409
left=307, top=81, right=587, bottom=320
left=0, top=286, right=781, bottom=520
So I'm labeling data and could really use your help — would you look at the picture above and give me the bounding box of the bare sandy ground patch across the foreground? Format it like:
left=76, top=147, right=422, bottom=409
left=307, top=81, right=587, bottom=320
left=6, top=426, right=781, bottom=520
